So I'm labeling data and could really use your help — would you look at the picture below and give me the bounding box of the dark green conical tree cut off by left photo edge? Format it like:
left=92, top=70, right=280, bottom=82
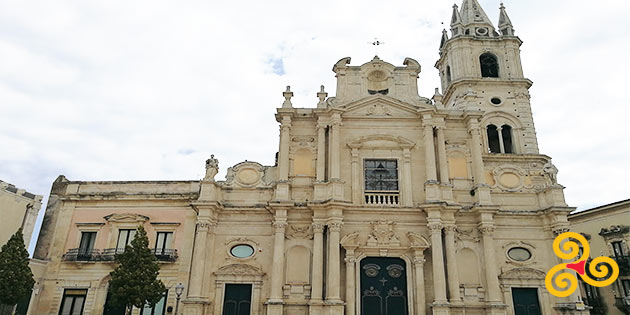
left=0, top=229, right=35, bottom=305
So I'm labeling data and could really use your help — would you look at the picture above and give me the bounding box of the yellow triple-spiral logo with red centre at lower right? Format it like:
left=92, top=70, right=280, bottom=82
left=545, top=232, right=619, bottom=297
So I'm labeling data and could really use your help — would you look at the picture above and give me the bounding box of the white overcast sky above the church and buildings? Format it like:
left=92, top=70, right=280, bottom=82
left=0, top=0, right=630, bottom=256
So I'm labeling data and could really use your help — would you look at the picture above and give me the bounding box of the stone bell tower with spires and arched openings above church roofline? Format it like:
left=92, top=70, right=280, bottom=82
left=435, top=0, right=538, bottom=154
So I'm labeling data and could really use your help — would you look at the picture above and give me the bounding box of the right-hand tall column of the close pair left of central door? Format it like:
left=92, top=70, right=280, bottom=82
left=326, top=221, right=342, bottom=303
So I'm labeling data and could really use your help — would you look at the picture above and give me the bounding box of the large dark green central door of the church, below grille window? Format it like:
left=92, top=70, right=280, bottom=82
left=360, top=257, right=408, bottom=315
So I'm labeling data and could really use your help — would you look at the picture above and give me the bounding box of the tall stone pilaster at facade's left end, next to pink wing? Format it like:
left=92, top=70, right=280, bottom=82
left=188, top=219, right=212, bottom=298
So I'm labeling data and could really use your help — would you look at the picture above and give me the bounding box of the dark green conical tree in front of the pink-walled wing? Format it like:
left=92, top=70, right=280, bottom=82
left=109, top=225, right=166, bottom=314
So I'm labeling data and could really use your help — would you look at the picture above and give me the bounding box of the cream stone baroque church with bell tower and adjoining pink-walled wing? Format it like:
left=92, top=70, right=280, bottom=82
left=29, top=0, right=588, bottom=315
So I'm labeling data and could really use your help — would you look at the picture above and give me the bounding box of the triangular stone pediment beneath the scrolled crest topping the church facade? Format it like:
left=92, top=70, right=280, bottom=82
left=340, top=96, right=428, bottom=118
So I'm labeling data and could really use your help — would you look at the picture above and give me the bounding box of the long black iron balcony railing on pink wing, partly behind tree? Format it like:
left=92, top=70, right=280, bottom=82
left=62, top=248, right=178, bottom=262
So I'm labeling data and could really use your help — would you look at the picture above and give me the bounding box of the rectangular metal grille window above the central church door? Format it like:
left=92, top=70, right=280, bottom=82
left=364, top=160, right=398, bottom=191
